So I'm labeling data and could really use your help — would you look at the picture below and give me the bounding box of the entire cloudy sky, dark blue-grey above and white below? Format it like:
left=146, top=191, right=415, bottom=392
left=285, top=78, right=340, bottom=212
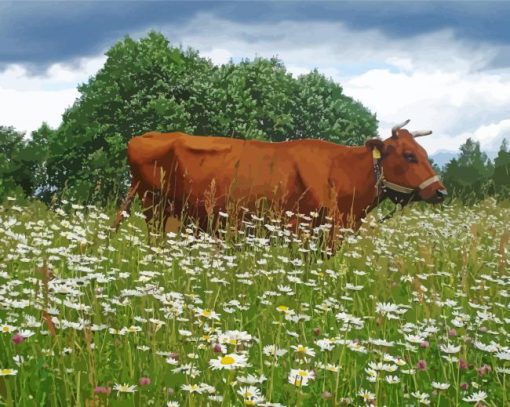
left=0, top=0, right=510, bottom=154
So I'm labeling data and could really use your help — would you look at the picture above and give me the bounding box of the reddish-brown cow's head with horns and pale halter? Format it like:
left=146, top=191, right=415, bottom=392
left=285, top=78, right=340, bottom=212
left=367, top=120, right=447, bottom=203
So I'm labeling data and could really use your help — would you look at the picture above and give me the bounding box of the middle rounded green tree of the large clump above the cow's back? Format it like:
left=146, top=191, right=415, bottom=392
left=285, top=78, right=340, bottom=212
left=206, top=58, right=296, bottom=141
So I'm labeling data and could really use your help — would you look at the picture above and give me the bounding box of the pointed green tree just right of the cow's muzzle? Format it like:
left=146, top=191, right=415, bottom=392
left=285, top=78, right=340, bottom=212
left=443, top=138, right=493, bottom=200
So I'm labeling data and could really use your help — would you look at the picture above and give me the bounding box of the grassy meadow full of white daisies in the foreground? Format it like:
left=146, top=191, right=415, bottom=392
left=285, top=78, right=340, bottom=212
left=0, top=199, right=510, bottom=407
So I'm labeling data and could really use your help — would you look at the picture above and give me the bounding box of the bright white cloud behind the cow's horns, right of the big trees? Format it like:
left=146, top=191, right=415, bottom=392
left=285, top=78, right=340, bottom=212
left=343, top=70, right=510, bottom=153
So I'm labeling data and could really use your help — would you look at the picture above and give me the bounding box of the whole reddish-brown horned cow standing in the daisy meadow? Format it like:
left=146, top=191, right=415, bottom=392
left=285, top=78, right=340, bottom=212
left=114, top=121, right=446, bottom=237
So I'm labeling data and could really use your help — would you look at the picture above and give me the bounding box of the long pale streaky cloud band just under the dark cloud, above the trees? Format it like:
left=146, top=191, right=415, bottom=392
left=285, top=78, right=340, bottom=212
left=169, top=13, right=498, bottom=74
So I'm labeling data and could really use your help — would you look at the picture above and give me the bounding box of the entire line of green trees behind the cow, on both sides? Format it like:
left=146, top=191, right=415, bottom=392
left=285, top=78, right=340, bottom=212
left=0, top=32, right=510, bottom=204
